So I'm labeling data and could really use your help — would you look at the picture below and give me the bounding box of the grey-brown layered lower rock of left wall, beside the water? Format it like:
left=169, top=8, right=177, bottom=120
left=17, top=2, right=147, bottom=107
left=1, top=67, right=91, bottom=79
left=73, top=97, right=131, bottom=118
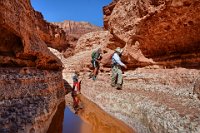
left=0, top=67, right=64, bottom=133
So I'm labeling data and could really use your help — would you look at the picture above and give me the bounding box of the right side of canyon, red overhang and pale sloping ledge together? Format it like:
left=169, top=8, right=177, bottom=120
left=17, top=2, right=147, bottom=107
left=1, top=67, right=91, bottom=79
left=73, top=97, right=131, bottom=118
left=54, top=0, right=200, bottom=133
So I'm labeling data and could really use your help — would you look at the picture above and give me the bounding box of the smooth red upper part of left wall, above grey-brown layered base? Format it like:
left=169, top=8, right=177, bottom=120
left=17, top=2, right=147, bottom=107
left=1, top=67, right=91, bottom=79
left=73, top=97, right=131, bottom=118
left=0, top=0, right=67, bottom=70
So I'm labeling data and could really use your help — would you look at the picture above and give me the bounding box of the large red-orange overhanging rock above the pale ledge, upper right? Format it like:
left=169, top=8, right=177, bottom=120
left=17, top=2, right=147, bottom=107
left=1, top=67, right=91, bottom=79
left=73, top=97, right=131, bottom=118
left=104, top=0, right=200, bottom=68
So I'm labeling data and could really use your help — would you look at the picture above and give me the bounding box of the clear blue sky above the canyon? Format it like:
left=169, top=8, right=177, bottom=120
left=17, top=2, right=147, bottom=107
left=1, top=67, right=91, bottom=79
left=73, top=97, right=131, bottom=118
left=31, top=0, right=112, bottom=26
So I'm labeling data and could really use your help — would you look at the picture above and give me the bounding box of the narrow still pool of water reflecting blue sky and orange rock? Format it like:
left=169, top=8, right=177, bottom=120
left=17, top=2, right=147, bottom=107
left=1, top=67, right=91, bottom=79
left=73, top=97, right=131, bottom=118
left=47, top=94, right=134, bottom=133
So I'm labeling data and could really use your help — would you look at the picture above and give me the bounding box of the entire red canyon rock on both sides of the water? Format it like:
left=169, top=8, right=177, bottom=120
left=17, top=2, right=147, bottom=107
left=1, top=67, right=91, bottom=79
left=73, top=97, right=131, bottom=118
left=0, top=0, right=200, bottom=133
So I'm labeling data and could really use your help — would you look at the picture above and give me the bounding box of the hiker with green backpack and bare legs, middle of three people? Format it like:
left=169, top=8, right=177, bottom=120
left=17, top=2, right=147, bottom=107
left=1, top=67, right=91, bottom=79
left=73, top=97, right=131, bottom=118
left=90, top=48, right=101, bottom=81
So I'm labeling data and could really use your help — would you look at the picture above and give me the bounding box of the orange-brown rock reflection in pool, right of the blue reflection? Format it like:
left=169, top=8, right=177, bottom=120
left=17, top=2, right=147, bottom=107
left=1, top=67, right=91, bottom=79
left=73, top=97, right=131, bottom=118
left=78, top=96, right=134, bottom=133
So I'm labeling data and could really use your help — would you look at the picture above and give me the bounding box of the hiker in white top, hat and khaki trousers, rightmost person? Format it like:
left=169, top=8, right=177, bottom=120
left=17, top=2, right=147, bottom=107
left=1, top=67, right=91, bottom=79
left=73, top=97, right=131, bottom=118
left=111, top=47, right=127, bottom=89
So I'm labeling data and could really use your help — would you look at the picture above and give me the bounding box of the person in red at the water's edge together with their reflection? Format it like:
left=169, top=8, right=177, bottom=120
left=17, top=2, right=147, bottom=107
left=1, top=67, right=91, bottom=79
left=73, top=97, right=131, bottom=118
left=72, top=71, right=81, bottom=110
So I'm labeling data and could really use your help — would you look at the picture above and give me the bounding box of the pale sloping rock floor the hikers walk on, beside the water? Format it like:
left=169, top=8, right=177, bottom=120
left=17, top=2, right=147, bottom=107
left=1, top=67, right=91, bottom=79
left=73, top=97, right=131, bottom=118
left=50, top=48, right=200, bottom=133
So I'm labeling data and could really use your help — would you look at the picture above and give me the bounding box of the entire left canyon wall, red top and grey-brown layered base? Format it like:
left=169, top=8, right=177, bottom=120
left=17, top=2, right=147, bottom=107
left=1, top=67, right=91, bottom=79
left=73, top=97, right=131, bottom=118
left=0, top=0, right=65, bottom=133
